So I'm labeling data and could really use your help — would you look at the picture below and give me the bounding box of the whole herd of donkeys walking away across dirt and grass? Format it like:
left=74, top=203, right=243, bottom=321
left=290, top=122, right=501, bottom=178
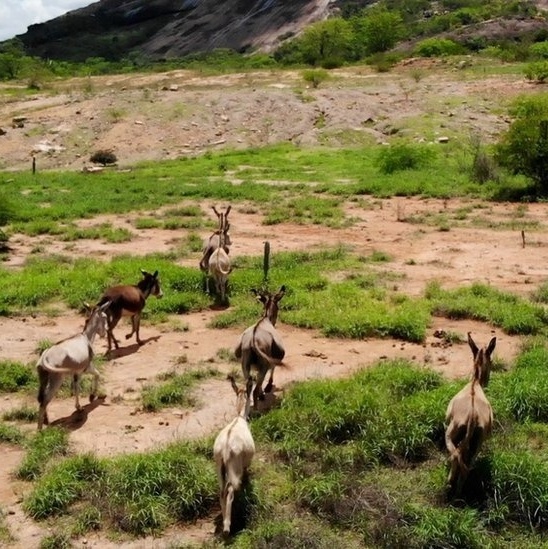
left=33, top=206, right=496, bottom=535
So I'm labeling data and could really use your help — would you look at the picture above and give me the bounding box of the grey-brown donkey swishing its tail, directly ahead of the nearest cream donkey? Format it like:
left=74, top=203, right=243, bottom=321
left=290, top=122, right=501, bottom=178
left=234, top=286, right=285, bottom=409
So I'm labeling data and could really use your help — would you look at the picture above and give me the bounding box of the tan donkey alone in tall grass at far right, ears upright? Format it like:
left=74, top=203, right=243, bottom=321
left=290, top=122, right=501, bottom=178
left=445, top=332, right=497, bottom=495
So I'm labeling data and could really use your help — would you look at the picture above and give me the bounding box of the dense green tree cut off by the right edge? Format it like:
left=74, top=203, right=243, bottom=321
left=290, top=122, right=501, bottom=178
left=496, top=95, right=548, bottom=196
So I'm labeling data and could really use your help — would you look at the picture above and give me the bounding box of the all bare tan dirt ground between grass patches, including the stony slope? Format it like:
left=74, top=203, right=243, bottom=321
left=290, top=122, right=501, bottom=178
left=0, top=62, right=548, bottom=549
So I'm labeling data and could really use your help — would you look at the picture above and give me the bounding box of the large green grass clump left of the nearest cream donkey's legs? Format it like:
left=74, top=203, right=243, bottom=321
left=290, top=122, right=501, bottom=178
left=24, top=443, right=218, bottom=536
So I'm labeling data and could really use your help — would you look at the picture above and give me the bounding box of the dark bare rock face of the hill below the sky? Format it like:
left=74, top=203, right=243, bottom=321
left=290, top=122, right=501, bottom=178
left=19, top=0, right=371, bottom=61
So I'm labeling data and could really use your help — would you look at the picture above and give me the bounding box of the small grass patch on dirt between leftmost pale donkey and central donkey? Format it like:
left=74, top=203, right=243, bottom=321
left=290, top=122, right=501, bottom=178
left=142, top=368, right=219, bottom=412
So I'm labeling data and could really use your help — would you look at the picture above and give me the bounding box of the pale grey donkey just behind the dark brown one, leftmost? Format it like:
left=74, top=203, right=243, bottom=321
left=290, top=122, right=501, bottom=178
left=36, top=301, right=110, bottom=430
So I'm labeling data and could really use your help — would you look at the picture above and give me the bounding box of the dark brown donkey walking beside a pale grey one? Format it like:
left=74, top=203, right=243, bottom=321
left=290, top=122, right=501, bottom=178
left=97, top=269, right=164, bottom=354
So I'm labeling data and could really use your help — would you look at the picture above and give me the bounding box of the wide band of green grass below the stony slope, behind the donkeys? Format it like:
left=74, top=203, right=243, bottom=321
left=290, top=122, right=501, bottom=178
left=0, top=140, right=528, bottom=237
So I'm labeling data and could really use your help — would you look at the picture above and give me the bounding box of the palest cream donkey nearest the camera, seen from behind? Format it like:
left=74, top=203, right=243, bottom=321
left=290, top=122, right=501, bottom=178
left=213, top=376, right=255, bottom=536
